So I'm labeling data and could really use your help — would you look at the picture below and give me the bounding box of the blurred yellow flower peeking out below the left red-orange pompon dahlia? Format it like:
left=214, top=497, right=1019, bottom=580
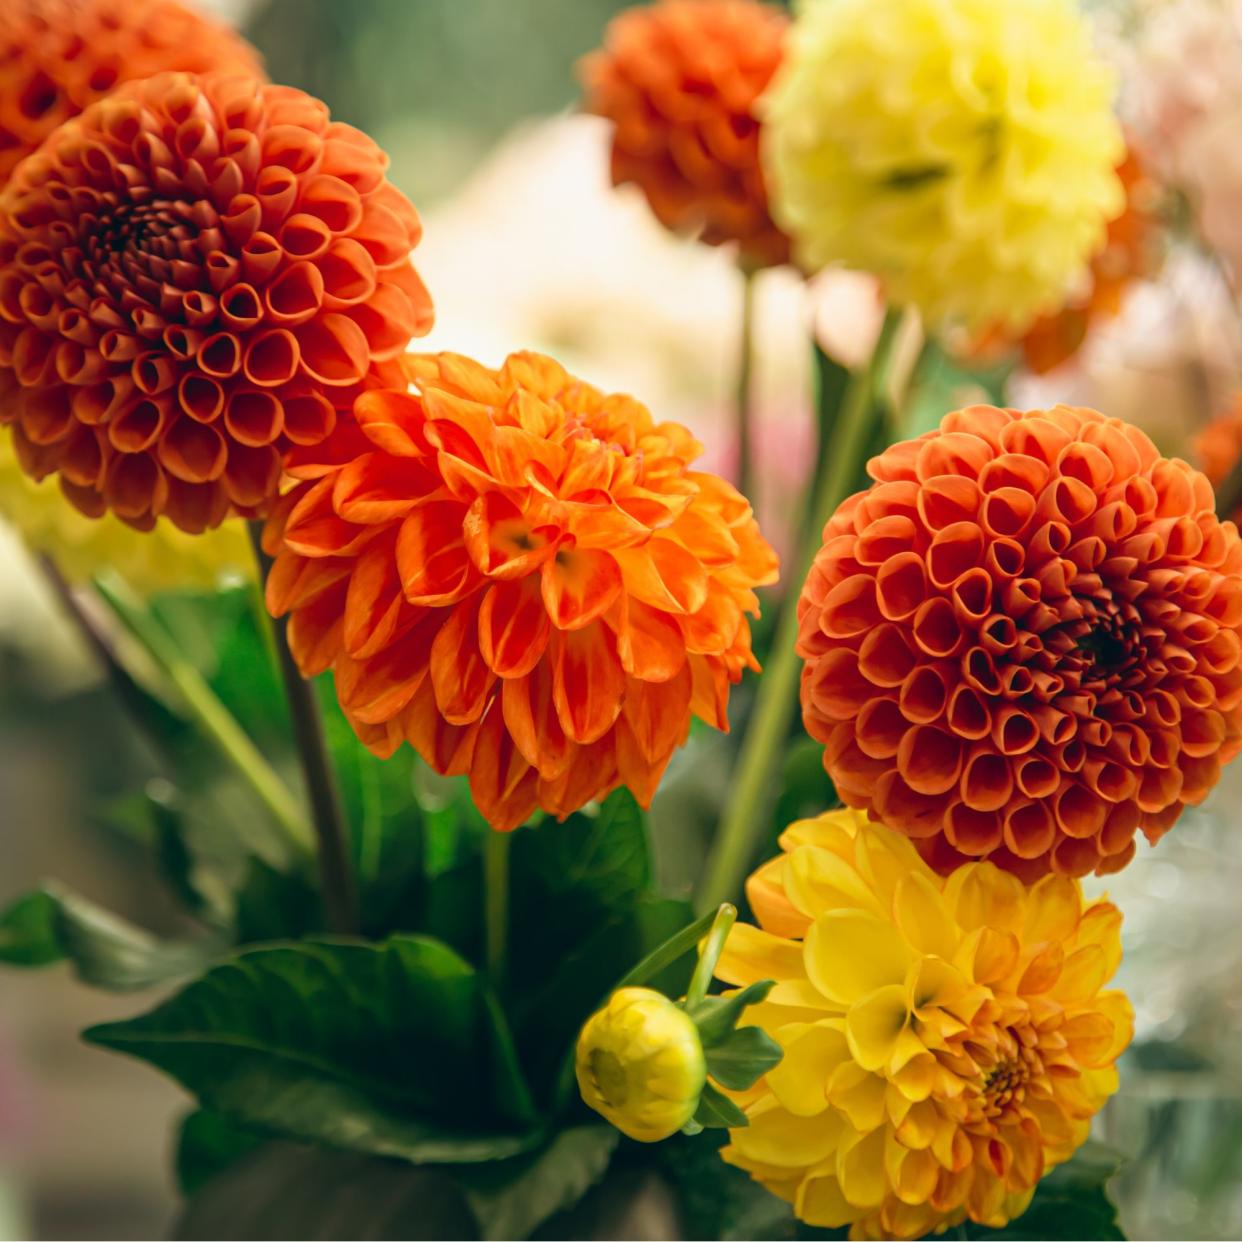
left=0, top=430, right=253, bottom=595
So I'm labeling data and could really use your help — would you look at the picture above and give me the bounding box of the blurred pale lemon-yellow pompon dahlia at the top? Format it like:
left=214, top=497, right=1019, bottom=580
left=761, top=0, right=1124, bottom=332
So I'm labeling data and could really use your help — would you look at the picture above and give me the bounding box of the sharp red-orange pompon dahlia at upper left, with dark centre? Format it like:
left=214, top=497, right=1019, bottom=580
left=0, top=73, right=431, bottom=532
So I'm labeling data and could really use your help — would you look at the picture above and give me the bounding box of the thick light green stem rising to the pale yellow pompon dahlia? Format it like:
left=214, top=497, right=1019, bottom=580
left=696, top=313, right=897, bottom=910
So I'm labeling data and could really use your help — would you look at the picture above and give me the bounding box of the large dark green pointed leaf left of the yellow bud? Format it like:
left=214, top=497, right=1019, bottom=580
left=86, top=936, right=539, bottom=1164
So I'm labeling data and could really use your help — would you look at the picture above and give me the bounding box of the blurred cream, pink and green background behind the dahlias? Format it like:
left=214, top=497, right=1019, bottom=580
left=0, top=0, right=1242, bottom=1238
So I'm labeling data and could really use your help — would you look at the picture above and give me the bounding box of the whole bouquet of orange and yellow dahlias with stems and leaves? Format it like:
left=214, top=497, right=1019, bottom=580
left=0, top=0, right=1242, bottom=1238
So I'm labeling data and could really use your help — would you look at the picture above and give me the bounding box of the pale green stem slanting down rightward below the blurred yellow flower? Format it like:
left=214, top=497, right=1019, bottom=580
left=94, top=573, right=312, bottom=853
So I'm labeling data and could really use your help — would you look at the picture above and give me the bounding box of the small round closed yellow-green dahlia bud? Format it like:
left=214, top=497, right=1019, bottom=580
left=575, top=987, right=707, bottom=1143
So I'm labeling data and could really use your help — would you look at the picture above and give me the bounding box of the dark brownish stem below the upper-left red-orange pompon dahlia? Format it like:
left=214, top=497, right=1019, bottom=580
left=250, top=522, right=358, bottom=933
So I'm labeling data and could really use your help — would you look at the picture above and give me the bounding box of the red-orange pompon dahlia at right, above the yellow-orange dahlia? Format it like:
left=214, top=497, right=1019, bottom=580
left=799, top=406, right=1242, bottom=879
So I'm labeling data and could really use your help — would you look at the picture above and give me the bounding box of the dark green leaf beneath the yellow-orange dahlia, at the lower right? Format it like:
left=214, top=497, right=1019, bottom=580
left=964, top=1141, right=1125, bottom=1242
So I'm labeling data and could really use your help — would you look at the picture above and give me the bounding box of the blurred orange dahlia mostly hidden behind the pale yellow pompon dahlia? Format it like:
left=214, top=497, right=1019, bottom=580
left=1018, top=150, right=1159, bottom=375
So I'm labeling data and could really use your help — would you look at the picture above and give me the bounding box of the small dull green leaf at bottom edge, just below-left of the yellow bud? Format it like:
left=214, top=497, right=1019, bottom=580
left=456, top=1125, right=620, bottom=1242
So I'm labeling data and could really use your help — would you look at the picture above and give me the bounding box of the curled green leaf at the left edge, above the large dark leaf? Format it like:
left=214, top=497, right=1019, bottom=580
left=0, top=884, right=222, bottom=992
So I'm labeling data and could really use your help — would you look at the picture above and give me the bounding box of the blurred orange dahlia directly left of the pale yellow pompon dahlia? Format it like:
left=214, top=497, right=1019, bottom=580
left=580, top=0, right=789, bottom=267
